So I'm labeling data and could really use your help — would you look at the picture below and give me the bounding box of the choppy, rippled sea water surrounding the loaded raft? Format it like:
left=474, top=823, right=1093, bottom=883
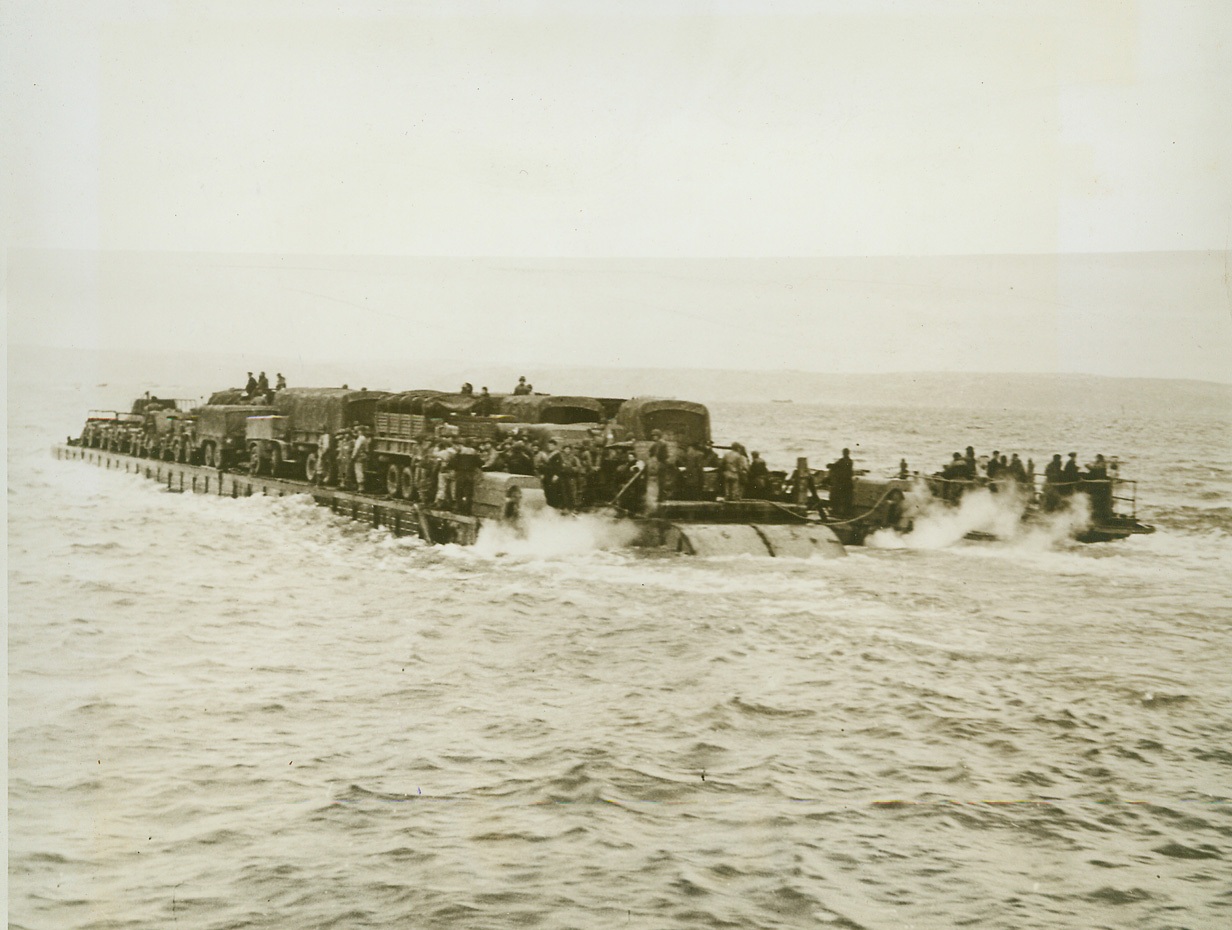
left=9, top=386, right=1232, bottom=930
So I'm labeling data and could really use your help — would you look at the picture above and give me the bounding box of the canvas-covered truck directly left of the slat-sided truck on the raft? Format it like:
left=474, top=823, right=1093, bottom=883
left=246, top=388, right=389, bottom=480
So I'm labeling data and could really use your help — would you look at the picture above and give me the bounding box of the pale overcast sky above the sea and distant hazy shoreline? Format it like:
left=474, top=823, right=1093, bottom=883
left=0, top=0, right=1232, bottom=381
